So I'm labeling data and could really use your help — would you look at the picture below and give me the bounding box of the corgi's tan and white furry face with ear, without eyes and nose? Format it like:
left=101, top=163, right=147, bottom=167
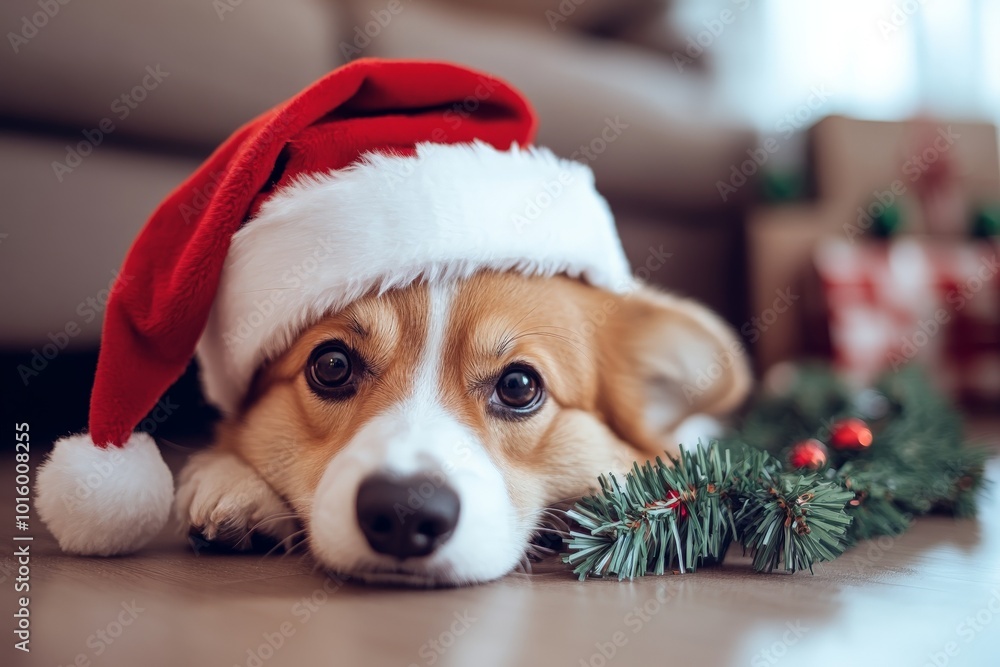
left=203, top=273, right=749, bottom=584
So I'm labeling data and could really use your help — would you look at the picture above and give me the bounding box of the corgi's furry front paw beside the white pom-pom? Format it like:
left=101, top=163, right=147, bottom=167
left=175, top=450, right=300, bottom=550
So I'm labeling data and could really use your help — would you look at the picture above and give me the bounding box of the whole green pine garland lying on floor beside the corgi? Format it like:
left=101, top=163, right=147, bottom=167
left=563, top=368, right=986, bottom=579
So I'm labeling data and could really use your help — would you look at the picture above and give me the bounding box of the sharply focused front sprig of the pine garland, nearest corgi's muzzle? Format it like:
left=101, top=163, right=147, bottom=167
left=564, top=444, right=854, bottom=579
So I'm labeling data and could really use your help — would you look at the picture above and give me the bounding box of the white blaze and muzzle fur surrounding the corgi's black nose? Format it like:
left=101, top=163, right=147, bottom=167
left=310, top=285, right=531, bottom=582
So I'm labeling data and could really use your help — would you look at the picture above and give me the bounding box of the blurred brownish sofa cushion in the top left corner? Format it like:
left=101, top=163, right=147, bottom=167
left=0, top=0, right=340, bottom=147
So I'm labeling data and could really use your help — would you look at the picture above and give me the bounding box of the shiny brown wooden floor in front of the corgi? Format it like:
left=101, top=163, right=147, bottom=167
left=0, top=421, right=1000, bottom=667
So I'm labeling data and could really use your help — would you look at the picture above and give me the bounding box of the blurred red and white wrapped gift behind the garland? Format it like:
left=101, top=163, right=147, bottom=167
left=815, top=237, right=1000, bottom=401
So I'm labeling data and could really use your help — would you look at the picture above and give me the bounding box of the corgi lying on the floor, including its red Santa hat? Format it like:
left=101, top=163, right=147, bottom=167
left=36, top=59, right=750, bottom=586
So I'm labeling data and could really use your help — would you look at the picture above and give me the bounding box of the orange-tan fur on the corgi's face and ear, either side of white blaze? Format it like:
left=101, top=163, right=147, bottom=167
left=179, top=273, right=750, bottom=568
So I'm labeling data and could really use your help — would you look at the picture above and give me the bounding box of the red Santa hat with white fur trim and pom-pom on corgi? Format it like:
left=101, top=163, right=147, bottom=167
left=36, top=59, right=631, bottom=555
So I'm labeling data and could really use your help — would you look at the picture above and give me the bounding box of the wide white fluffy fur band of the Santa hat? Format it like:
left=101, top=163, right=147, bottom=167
left=198, top=143, right=633, bottom=413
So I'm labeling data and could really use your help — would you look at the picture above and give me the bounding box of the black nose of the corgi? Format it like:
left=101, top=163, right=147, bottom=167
left=357, top=475, right=460, bottom=559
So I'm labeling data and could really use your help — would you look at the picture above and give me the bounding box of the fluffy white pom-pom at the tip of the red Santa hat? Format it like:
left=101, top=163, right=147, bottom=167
left=35, top=433, right=174, bottom=556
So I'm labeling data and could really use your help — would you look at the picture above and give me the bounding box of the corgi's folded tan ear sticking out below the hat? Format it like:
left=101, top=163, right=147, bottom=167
left=595, top=287, right=751, bottom=452
